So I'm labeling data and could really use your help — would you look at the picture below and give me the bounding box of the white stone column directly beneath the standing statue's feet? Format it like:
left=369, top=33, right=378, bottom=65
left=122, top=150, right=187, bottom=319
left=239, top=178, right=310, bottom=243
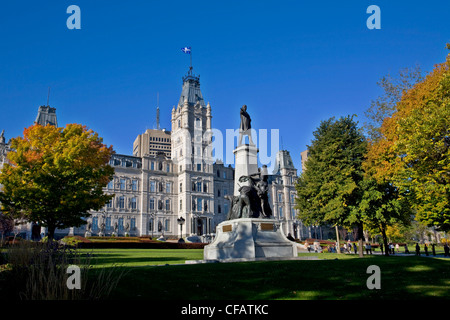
left=233, top=144, right=258, bottom=196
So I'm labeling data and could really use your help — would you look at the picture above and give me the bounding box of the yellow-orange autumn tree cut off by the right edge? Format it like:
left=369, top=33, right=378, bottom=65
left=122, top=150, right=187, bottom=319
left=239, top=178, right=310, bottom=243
left=368, top=51, right=450, bottom=231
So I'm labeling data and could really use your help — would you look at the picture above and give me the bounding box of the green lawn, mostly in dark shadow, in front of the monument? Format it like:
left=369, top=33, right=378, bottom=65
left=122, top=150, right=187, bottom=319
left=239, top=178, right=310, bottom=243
left=81, top=249, right=450, bottom=300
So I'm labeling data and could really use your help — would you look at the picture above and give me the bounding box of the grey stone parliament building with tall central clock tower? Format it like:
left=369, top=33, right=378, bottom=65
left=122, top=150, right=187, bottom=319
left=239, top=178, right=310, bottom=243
left=0, top=68, right=316, bottom=242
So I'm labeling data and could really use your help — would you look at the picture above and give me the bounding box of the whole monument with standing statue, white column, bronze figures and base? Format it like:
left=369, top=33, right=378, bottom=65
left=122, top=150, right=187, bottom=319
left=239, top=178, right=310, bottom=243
left=204, top=105, right=297, bottom=261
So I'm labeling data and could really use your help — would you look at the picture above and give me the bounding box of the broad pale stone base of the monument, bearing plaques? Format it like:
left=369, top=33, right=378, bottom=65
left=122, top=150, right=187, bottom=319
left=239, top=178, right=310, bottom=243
left=203, top=218, right=297, bottom=261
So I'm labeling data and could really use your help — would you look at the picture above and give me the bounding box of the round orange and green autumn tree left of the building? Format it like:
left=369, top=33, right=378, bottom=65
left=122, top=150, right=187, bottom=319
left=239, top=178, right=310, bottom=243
left=0, top=124, right=114, bottom=239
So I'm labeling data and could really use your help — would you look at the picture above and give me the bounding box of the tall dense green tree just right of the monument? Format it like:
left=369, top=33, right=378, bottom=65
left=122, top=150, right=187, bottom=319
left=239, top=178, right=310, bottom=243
left=296, top=116, right=366, bottom=255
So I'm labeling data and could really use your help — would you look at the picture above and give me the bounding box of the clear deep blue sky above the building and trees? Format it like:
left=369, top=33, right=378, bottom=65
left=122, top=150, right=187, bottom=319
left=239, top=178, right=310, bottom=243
left=0, top=0, right=450, bottom=172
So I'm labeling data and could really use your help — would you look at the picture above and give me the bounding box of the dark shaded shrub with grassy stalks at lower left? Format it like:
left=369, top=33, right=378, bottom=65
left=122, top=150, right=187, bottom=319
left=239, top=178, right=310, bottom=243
left=3, top=241, right=124, bottom=300
